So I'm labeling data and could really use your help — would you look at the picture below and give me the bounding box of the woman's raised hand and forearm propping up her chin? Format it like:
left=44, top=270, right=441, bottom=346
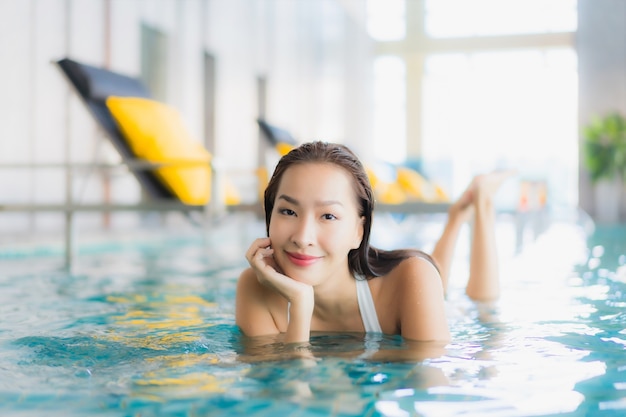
left=246, top=238, right=314, bottom=343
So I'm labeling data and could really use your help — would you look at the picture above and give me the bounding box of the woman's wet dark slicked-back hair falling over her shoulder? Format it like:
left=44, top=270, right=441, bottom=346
left=264, top=141, right=438, bottom=279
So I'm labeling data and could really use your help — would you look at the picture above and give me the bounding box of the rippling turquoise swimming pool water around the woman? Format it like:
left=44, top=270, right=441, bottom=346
left=0, top=213, right=626, bottom=417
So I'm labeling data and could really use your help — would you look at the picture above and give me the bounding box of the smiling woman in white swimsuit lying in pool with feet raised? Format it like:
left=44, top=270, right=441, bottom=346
left=236, top=142, right=506, bottom=343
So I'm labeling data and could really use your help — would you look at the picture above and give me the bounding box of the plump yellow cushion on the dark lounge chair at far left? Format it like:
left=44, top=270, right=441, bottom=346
left=106, top=97, right=211, bottom=205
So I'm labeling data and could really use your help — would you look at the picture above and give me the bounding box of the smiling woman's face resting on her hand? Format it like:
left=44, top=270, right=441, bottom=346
left=269, top=163, right=363, bottom=285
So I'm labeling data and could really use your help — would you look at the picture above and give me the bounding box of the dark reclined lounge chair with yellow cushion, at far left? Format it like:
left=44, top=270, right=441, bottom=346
left=56, top=58, right=250, bottom=209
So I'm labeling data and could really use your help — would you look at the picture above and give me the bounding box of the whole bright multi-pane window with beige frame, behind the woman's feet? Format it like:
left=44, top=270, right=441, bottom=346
left=367, top=0, right=578, bottom=205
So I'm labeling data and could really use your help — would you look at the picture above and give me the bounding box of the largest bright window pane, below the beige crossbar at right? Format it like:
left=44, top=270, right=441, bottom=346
left=422, top=48, right=578, bottom=204
